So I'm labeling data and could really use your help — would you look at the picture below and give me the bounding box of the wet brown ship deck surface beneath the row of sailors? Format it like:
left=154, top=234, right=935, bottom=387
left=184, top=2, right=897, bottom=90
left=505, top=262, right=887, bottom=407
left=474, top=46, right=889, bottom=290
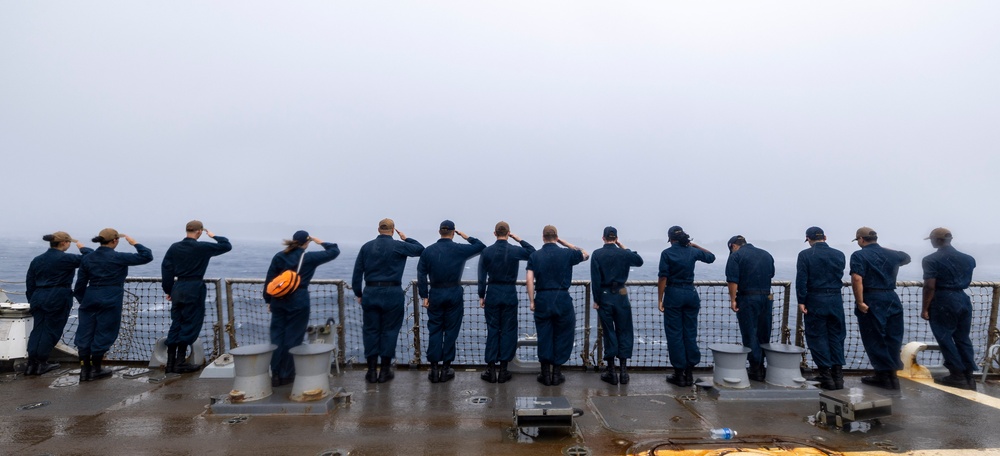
left=0, top=364, right=1000, bottom=455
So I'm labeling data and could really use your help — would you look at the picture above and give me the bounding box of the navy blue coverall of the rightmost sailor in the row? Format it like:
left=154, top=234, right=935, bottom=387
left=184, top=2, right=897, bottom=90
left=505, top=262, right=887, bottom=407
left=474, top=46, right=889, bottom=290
left=923, top=245, right=976, bottom=374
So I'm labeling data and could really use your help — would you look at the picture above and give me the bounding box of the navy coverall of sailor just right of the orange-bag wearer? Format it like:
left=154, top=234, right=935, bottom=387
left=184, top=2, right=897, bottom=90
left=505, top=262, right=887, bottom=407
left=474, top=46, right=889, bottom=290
left=351, top=234, right=424, bottom=360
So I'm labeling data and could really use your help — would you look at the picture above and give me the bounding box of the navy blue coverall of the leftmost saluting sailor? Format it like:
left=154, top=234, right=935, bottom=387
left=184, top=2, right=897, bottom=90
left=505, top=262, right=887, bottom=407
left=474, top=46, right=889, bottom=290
left=24, top=247, right=94, bottom=362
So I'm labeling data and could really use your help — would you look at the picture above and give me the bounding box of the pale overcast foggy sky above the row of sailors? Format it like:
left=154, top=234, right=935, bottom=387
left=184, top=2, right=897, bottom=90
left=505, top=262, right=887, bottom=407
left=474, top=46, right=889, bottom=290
left=0, top=1, right=1000, bottom=250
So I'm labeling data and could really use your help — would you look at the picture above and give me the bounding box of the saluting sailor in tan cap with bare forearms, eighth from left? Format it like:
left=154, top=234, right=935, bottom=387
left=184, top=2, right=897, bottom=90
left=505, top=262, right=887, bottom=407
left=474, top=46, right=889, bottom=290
left=526, top=225, right=590, bottom=386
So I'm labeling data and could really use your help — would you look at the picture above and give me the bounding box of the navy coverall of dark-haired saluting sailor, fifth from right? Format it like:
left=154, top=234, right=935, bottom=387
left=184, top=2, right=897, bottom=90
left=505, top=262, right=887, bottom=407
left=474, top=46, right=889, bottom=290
left=657, top=243, right=715, bottom=369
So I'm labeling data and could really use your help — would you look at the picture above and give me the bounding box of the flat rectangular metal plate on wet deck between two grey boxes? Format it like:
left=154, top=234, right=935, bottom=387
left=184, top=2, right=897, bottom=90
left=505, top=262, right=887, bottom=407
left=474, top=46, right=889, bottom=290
left=589, top=395, right=709, bottom=433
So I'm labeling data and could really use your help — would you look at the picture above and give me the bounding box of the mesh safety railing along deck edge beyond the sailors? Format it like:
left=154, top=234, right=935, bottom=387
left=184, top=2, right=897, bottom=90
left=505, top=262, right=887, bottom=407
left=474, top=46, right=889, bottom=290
left=41, top=277, right=1000, bottom=372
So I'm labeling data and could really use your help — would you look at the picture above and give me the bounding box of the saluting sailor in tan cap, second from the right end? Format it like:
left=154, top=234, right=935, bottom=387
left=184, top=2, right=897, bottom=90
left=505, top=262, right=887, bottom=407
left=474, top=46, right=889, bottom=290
left=850, top=226, right=910, bottom=390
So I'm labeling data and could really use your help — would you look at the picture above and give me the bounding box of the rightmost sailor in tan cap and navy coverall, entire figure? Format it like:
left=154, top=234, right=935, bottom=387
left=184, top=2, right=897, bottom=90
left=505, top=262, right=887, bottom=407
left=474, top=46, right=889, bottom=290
left=920, top=228, right=976, bottom=391
